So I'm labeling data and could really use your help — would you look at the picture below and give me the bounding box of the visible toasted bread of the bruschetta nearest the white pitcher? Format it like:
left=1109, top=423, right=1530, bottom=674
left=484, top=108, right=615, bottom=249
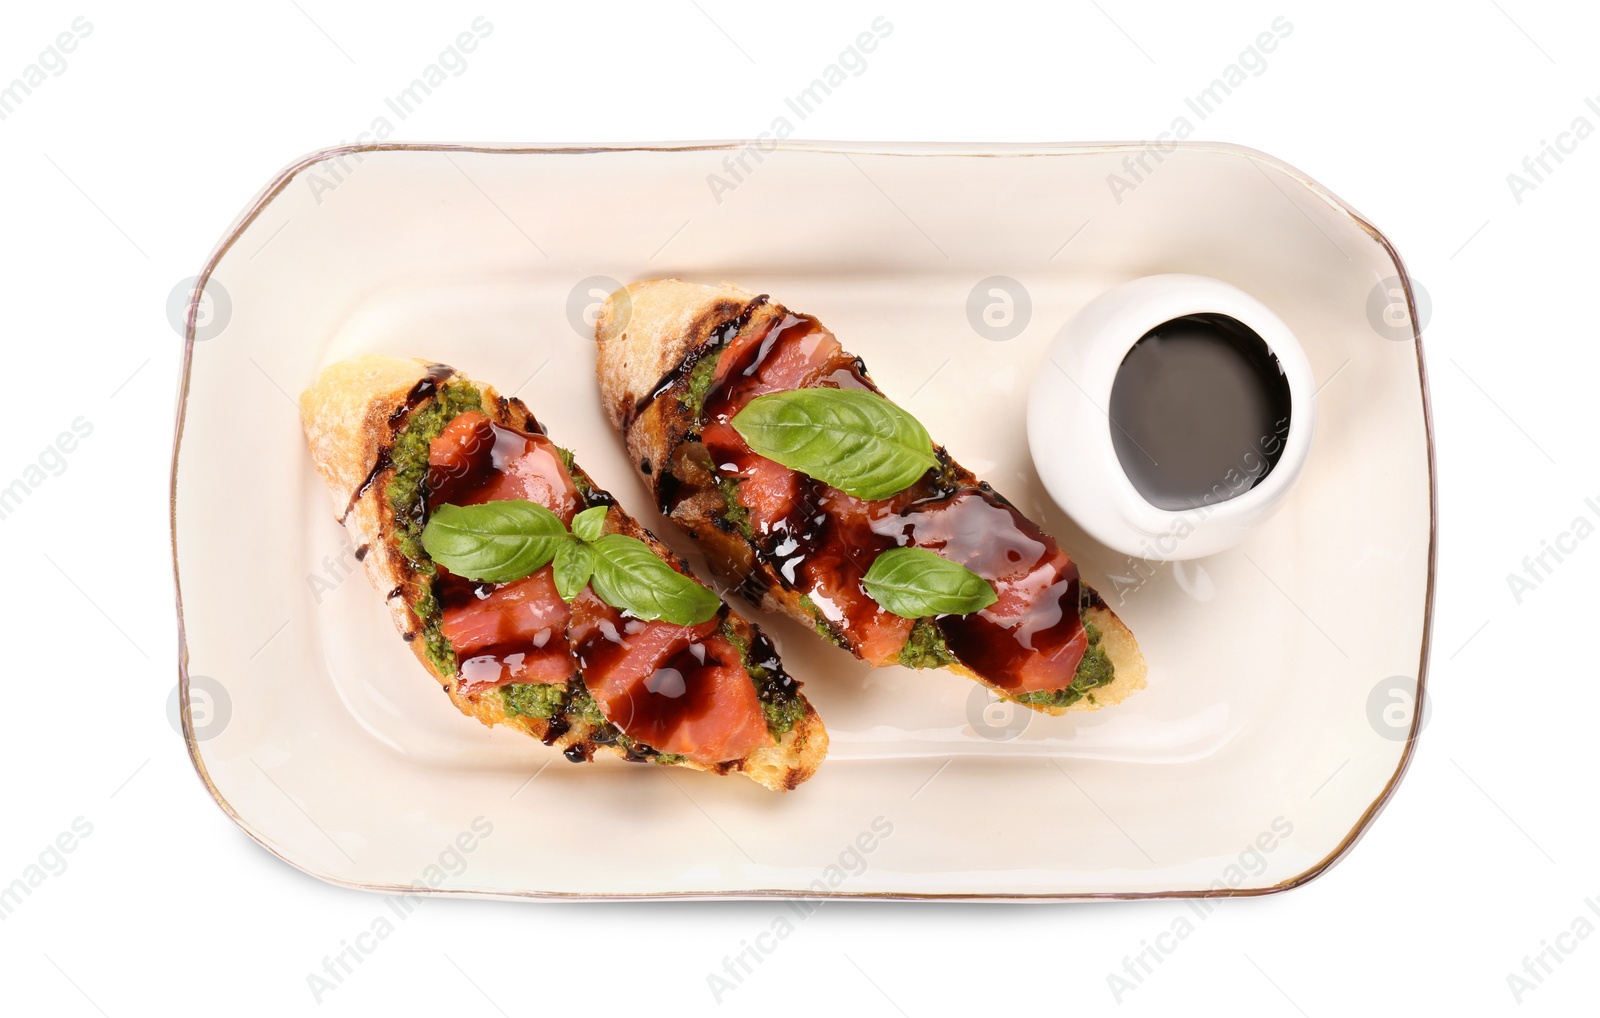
left=595, top=279, right=1147, bottom=714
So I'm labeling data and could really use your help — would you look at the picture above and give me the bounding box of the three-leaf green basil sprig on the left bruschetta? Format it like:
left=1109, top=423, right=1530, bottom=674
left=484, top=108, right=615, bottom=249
left=422, top=499, right=722, bottom=626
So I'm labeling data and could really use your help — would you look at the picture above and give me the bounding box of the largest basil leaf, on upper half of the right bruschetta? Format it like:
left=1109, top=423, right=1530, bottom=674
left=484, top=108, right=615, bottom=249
left=731, top=389, right=939, bottom=501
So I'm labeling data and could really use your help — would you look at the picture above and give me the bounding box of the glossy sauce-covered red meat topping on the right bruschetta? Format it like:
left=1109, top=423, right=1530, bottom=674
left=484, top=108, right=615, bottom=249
left=688, top=314, right=1086, bottom=693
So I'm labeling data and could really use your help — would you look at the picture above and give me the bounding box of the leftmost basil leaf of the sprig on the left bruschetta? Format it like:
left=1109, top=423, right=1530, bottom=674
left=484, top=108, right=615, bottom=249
left=422, top=498, right=568, bottom=583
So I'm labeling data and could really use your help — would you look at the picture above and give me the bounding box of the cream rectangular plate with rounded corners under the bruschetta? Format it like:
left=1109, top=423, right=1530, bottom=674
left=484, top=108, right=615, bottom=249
left=173, top=144, right=1434, bottom=898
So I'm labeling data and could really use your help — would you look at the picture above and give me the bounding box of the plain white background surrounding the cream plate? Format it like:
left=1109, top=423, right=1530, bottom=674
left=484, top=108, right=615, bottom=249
left=0, top=0, right=1600, bottom=1016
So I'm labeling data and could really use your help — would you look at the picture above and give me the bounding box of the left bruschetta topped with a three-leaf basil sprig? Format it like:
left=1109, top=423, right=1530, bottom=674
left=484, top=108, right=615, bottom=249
left=301, top=357, right=827, bottom=791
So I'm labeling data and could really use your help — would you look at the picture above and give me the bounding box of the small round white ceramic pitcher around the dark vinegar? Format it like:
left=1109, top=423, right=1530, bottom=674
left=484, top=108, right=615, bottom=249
left=1027, top=272, right=1317, bottom=562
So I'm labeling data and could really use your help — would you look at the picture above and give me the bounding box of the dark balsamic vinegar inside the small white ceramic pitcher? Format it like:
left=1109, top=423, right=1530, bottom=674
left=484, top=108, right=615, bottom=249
left=1109, top=314, right=1291, bottom=511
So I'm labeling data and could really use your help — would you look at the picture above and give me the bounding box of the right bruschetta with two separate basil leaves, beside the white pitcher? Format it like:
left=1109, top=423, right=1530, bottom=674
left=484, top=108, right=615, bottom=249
left=595, top=279, right=1146, bottom=714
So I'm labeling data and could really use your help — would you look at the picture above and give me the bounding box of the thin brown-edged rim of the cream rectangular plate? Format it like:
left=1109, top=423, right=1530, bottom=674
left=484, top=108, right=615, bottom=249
left=168, top=139, right=1438, bottom=903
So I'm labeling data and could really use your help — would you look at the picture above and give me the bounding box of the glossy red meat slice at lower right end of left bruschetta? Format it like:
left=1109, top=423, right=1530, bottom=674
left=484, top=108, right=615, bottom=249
left=568, top=591, right=771, bottom=765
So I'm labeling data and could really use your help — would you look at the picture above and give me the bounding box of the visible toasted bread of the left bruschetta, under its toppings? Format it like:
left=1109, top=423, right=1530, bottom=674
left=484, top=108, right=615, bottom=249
left=301, top=355, right=827, bottom=791
